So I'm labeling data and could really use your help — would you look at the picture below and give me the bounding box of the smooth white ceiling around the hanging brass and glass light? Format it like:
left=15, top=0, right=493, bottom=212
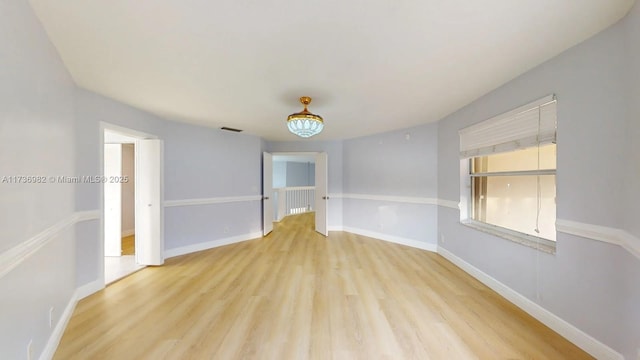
left=30, top=0, right=634, bottom=140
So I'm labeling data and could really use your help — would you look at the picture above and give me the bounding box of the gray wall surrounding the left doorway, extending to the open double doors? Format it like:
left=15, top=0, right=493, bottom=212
left=76, top=89, right=262, bottom=285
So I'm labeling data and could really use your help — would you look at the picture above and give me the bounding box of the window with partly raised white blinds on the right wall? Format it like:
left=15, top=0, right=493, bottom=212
left=459, top=95, right=557, bottom=252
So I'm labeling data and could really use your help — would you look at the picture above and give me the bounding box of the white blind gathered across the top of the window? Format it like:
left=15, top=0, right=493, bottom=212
left=458, top=95, right=557, bottom=158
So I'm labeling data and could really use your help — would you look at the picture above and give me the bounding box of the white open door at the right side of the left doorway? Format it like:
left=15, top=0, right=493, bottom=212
left=135, top=139, right=164, bottom=265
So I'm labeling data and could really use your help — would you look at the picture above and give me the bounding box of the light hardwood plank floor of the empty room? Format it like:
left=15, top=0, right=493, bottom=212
left=55, top=214, right=591, bottom=360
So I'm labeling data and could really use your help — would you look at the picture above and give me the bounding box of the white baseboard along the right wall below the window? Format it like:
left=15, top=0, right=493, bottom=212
left=438, top=247, right=624, bottom=360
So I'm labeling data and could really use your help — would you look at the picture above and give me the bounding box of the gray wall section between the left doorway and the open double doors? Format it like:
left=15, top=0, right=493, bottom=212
left=165, top=122, right=262, bottom=250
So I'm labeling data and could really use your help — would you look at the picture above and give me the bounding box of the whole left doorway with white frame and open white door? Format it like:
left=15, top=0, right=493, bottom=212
left=101, top=124, right=164, bottom=284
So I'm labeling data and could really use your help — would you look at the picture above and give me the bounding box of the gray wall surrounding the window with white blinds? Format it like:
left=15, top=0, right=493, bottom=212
left=438, top=5, right=640, bottom=359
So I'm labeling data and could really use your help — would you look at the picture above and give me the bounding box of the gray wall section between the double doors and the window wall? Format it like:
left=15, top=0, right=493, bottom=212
left=343, top=124, right=438, bottom=245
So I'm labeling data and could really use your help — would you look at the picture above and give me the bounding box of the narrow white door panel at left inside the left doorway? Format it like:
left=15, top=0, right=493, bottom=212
left=104, top=144, right=122, bottom=256
